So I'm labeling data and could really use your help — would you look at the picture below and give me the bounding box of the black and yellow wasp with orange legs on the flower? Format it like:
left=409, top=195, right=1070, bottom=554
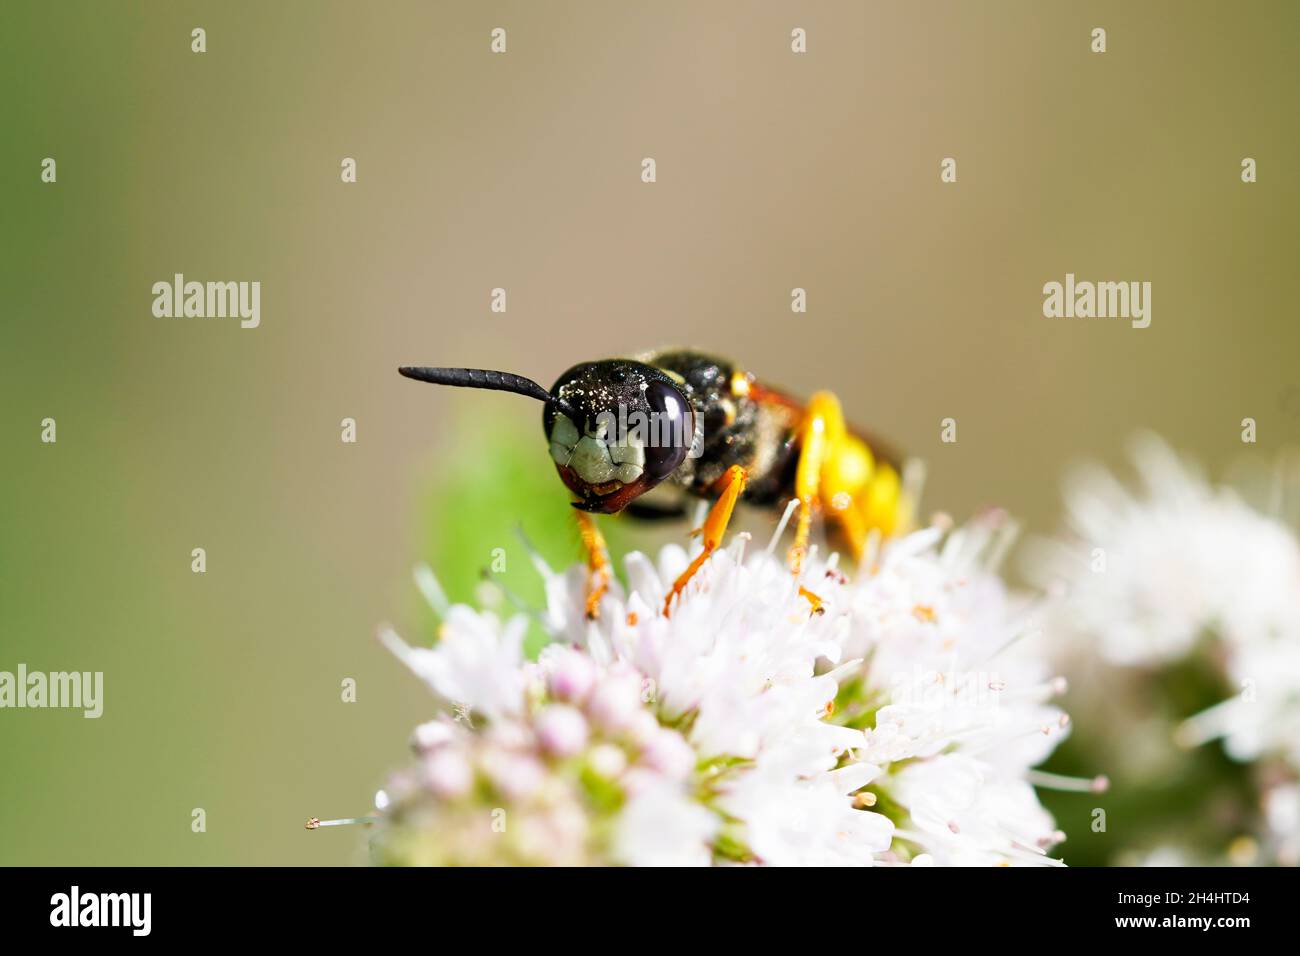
left=398, top=349, right=917, bottom=618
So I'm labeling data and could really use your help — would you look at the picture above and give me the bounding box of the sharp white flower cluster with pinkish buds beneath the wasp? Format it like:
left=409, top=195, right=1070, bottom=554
left=376, top=519, right=1067, bottom=865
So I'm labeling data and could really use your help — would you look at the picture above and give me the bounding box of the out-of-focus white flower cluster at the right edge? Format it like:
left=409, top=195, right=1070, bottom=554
left=1032, top=436, right=1300, bottom=769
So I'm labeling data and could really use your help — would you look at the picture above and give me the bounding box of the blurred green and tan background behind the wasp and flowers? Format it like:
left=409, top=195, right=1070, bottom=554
left=0, top=0, right=1300, bottom=864
